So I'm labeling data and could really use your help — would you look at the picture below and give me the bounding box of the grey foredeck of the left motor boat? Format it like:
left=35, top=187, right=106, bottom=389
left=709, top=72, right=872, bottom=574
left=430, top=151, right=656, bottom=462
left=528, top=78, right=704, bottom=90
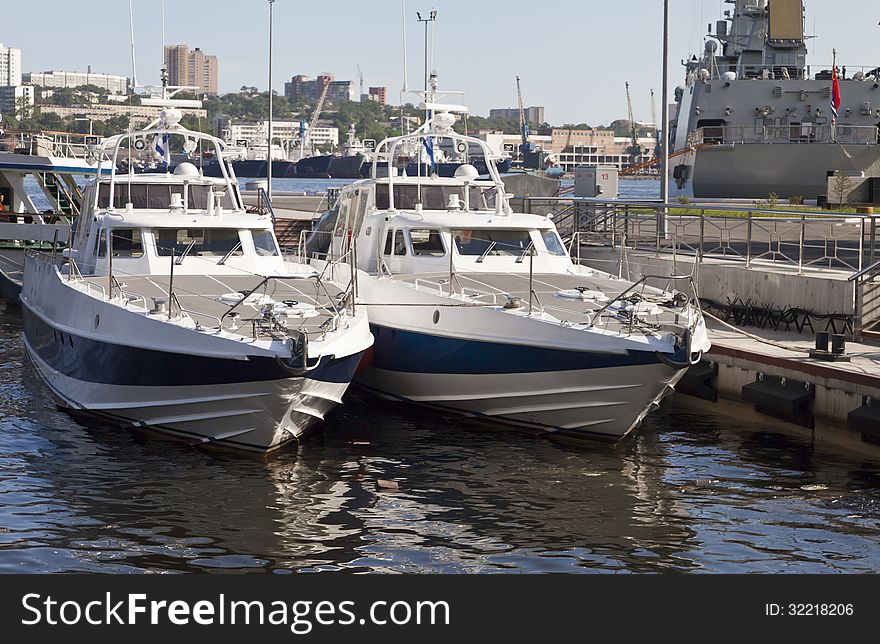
left=82, top=274, right=342, bottom=340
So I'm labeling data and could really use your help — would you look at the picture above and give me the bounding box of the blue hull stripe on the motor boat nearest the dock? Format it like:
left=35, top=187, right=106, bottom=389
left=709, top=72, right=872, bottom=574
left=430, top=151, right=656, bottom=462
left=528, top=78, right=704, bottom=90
left=370, top=324, right=660, bottom=375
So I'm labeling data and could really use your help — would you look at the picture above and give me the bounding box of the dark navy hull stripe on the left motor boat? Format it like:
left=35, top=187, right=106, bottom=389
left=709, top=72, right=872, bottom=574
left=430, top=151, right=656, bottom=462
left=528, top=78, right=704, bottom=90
left=22, top=307, right=361, bottom=387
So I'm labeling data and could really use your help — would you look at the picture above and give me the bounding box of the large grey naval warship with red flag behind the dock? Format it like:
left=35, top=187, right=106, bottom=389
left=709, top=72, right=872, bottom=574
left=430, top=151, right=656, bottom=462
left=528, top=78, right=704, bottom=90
left=670, top=0, right=880, bottom=199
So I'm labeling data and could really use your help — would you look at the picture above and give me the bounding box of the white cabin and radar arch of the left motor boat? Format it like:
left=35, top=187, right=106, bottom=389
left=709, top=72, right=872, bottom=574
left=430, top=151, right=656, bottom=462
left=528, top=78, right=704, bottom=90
left=68, top=110, right=284, bottom=276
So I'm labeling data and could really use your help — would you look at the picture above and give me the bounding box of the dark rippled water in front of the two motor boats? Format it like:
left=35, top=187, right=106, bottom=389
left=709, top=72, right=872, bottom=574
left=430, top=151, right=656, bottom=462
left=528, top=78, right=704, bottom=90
left=0, top=304, right=880, bottom=572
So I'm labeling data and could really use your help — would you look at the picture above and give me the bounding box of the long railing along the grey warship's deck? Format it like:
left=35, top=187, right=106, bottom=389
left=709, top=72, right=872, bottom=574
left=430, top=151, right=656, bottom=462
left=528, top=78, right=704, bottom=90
left=688, top=123, right=880, bottom=147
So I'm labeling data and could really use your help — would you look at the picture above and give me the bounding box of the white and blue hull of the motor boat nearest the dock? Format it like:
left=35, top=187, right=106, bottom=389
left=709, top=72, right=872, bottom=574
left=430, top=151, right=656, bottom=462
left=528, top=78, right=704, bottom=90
left=310, top=260, right=708, bottom=440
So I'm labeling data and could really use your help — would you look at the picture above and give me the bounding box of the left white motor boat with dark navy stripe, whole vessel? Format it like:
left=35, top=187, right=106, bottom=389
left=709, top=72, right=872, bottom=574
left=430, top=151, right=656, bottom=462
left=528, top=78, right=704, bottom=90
left=21, top=101, right=372, bottom=451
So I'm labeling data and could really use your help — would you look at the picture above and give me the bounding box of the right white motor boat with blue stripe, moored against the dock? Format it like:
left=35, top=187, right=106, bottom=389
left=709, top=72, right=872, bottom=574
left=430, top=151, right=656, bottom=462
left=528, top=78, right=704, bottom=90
left=302, top=93, right=710, bottom=440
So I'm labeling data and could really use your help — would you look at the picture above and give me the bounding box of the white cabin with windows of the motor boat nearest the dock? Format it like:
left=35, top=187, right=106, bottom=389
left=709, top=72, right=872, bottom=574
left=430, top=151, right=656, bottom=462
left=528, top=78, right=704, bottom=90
left=328, top=173, right=571, bottom=274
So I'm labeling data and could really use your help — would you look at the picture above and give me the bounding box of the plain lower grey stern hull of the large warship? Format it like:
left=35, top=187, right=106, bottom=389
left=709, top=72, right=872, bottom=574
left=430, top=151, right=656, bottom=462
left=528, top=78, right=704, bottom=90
left=679, top=143, right=880, bottom=199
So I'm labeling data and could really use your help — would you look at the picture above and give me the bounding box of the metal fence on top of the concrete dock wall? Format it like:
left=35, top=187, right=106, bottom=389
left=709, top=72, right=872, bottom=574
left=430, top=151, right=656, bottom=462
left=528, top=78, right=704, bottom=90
left=514, top=197, right=880, bottom=274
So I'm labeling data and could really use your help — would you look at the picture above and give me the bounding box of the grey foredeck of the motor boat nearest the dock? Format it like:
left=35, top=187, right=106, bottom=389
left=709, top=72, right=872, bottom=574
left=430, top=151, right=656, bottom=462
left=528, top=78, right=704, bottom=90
left=392, top=273, right=690, bottom=330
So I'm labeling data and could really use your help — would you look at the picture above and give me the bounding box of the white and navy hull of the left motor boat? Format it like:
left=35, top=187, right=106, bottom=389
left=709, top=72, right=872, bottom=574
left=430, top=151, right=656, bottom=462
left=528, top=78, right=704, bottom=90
left=22, top=257, right=371, bottom=451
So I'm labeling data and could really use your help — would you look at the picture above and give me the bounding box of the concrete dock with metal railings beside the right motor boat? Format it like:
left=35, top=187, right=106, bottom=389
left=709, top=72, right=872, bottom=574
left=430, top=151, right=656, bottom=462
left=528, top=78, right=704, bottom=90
left=520, top=198, right=880, bottom=458
